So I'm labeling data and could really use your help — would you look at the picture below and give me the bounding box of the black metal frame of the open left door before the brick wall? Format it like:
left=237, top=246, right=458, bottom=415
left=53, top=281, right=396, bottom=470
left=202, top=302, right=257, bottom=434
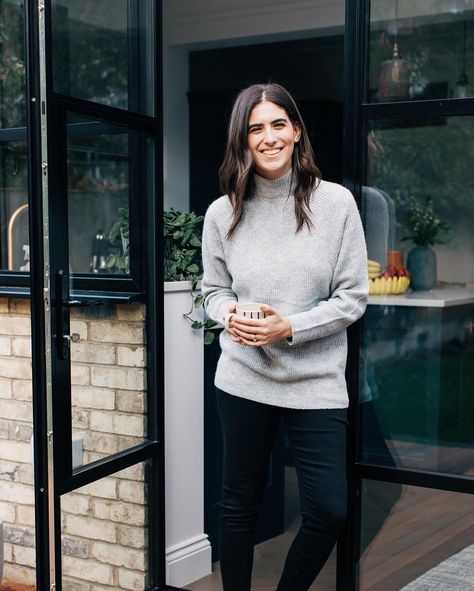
left=25, top=0, right=183, bottom=591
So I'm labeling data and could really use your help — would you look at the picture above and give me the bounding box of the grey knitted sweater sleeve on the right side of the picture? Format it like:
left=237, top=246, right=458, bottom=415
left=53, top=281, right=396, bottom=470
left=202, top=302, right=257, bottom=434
left=286, top=196, right=368, bottom=345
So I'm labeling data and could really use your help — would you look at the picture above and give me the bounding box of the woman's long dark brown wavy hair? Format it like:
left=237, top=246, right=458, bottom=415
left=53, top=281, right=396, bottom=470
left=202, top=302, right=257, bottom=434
left=219, top=83, right=321, bottom=238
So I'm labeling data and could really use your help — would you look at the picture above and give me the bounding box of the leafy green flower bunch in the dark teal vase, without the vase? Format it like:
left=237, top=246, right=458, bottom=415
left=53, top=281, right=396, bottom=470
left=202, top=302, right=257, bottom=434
left=402, top=197, right=451, bottom=245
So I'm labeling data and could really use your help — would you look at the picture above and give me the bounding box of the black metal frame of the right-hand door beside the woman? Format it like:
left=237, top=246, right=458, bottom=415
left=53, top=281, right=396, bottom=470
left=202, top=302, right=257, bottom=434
left=337, top=0, right=474, bottom=591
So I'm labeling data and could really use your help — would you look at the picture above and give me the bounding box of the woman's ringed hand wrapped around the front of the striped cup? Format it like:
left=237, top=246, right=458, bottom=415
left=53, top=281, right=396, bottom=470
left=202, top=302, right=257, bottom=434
left=229, top=305, right=292, bottom=347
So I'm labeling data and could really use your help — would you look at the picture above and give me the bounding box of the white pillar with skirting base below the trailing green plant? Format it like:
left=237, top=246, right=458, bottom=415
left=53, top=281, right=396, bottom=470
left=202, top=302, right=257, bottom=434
left=164, top=281, right=211, bottom=587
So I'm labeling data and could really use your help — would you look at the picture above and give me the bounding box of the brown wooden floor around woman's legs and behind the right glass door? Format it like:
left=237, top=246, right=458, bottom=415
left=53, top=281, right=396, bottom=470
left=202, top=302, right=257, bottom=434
left=186, top=455, right=474, bottom=591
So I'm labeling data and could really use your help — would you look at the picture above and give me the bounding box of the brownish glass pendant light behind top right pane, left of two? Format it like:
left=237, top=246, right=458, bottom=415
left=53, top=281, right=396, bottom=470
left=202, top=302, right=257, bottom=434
left=377, top=0, right=410, bottom=102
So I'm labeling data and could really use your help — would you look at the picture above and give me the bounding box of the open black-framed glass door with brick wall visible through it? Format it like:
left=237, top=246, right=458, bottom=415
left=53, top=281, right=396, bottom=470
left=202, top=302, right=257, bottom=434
left=27, top=0, right=171, bottom=590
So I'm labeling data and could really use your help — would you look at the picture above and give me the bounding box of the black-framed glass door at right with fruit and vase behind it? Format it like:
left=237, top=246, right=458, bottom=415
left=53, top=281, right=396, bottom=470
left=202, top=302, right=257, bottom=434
left=338, top=0, right=474, bottom=591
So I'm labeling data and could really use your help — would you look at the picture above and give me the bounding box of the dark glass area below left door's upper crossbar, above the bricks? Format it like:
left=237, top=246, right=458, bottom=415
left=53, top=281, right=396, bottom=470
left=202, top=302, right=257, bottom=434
left=68, top=116, right=132, bottom=274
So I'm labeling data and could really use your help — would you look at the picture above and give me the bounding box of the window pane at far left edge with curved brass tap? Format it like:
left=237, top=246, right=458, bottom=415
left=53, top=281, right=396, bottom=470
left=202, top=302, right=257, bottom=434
left=0, top=141, right=30, bottom=271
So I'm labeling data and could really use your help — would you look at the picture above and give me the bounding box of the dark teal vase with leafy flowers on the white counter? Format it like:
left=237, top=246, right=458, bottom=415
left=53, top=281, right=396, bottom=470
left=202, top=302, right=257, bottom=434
left=402, top=197, right=450, bottom=290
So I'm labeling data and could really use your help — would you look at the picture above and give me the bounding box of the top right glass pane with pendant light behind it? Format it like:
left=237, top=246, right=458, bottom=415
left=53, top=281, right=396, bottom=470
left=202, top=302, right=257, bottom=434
left=367, top=0, right=474, bottom=102
